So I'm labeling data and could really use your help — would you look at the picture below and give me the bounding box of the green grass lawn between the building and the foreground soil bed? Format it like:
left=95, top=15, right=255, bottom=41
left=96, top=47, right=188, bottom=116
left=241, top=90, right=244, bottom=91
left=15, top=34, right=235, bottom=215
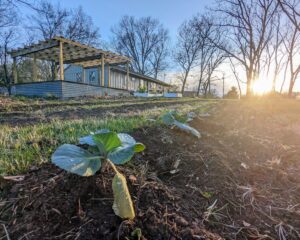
left=0, top=98, right=216, bottom=175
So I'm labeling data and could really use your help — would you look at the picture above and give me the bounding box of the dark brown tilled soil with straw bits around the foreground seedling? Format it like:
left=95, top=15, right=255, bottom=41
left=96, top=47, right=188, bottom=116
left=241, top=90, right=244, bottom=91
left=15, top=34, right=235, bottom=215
left=0, top=101, right=300, bottom=239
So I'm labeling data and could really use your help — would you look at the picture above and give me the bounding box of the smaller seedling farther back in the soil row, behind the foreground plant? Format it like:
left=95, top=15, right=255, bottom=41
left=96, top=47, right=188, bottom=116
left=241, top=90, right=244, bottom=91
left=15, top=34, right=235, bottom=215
left=161, top=111, right=201, bottom=138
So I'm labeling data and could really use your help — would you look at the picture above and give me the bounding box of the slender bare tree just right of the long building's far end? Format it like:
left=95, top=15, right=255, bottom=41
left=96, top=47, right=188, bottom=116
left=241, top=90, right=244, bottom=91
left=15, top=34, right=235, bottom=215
left=174, top=19, right=202, bottom=93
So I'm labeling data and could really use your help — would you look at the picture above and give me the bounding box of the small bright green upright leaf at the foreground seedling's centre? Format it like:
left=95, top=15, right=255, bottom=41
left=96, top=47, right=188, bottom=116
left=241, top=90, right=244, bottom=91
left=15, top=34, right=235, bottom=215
left=93, top=132, right=121, bottom=153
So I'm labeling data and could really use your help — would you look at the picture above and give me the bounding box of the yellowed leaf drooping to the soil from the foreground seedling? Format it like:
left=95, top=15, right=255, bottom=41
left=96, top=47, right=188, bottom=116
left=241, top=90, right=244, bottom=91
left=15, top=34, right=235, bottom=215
left=112, top=172, right=135, bottom=219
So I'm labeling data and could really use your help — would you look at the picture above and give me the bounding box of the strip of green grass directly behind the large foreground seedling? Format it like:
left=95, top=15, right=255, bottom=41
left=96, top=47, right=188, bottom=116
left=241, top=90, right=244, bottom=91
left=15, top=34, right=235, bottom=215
left=0, top=116, right=155, bottom=174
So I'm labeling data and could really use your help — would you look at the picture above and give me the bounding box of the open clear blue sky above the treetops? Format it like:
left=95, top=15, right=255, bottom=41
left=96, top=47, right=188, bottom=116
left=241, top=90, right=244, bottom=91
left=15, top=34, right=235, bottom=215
left=60, top=0, right=212, bottom=42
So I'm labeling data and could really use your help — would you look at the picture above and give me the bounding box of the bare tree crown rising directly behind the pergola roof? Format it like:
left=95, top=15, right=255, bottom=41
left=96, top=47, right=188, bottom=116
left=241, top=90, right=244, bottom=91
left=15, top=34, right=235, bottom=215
left=28, top=0, right=100, bottom=79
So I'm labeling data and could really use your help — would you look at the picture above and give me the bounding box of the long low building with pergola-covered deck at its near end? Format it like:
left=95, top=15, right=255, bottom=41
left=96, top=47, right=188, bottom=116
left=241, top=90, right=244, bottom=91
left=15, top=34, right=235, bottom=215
left=10, top=37, right=171, bottom=98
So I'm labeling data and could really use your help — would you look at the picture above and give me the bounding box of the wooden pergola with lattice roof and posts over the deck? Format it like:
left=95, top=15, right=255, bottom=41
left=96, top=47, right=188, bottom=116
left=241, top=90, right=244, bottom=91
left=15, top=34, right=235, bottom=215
left=10, top=37, right=130, bottom=86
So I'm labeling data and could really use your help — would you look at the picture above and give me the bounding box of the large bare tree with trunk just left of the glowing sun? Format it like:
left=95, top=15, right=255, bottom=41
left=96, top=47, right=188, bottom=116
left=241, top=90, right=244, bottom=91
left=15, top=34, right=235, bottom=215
left=215, top=0, right=278, bottom=96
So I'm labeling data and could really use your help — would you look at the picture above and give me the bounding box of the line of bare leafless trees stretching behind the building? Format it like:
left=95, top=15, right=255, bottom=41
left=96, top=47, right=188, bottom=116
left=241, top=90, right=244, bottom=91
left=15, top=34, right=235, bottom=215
left=0, top=0, right=300, bottom=96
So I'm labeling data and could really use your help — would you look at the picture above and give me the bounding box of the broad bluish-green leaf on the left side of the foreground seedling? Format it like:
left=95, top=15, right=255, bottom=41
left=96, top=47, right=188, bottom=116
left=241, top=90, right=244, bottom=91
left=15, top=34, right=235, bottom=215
left=51, top=144, right=101, bottom=177
